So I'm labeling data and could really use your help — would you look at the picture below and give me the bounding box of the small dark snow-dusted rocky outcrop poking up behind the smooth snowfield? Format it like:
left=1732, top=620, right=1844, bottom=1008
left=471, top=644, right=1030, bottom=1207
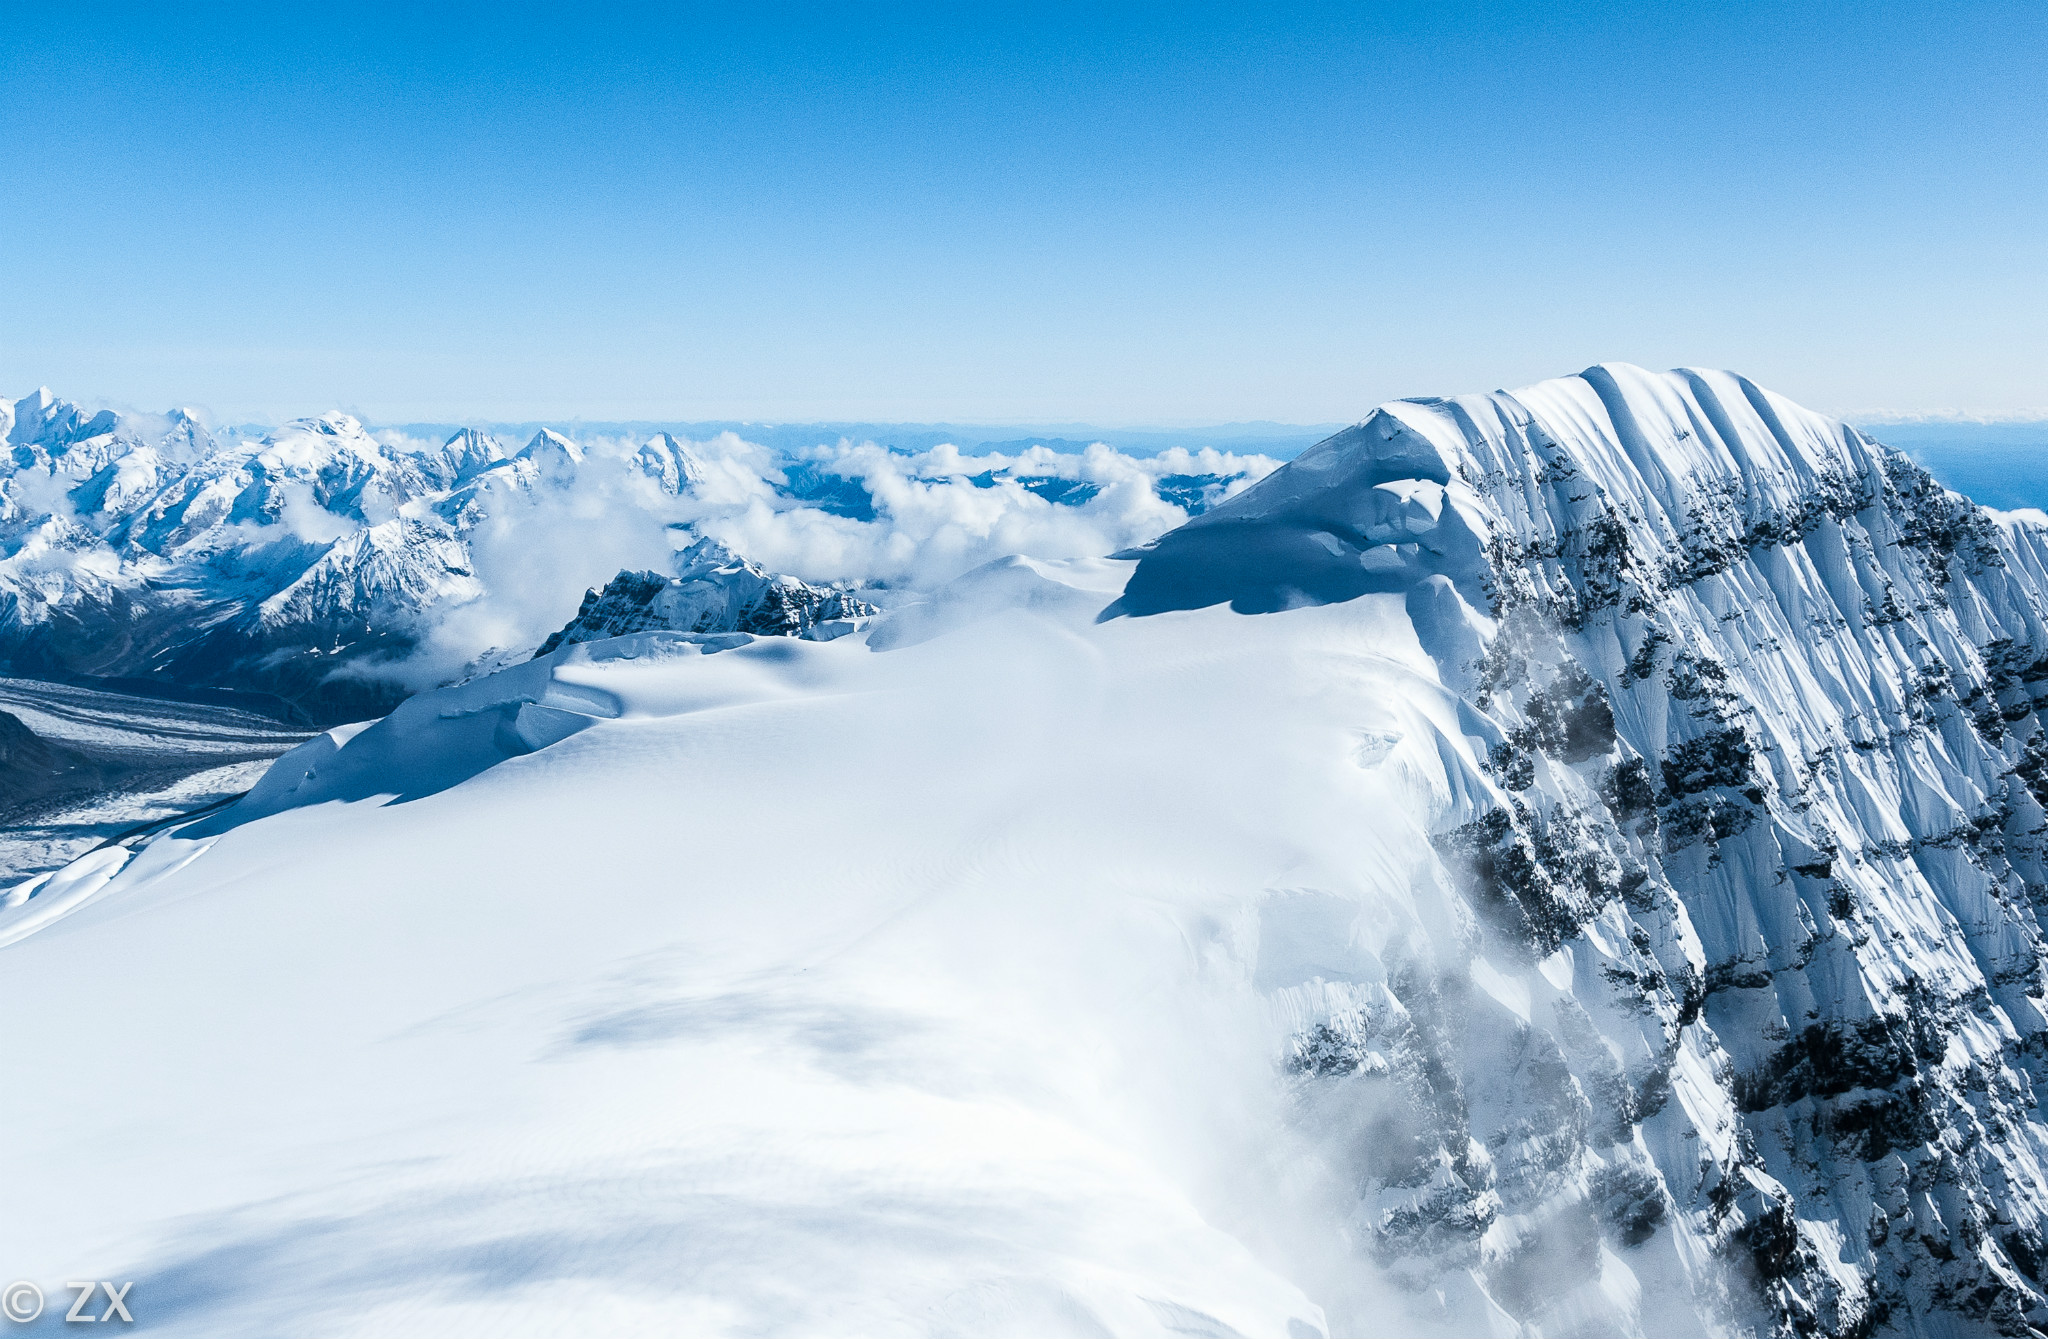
left=535, top=538, right=879, bottom=657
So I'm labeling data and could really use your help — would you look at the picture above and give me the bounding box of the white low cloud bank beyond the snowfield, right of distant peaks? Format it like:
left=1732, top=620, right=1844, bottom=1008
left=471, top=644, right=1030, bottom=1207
left=389, top=432, right=1278, bottom=688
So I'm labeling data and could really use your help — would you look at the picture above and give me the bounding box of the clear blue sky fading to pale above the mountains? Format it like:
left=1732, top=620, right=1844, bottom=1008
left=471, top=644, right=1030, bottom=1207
left=0, top=4, right=2048, bottom=424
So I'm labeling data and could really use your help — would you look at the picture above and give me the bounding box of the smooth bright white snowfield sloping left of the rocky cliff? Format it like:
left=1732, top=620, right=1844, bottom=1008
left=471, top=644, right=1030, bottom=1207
left=0, top=563, right=1456, bottom=1335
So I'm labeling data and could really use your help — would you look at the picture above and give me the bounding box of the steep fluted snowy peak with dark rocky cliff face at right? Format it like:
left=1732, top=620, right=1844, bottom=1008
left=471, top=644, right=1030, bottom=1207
left=1112, top=366, right=2048, bottom=1335
